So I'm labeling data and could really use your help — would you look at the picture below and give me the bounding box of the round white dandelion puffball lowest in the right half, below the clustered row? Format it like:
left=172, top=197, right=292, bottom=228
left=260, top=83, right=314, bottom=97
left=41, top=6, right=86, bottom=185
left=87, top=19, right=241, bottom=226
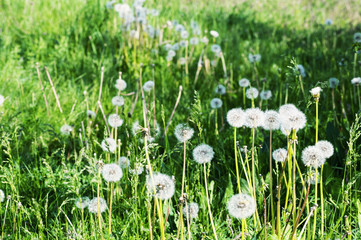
left=227, top=193, right=257, bottom=219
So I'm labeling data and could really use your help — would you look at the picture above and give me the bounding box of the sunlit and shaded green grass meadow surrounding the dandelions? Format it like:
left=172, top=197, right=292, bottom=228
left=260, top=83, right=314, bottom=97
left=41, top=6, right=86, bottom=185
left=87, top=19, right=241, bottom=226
left=0, top=0, right=361, bottom=239
